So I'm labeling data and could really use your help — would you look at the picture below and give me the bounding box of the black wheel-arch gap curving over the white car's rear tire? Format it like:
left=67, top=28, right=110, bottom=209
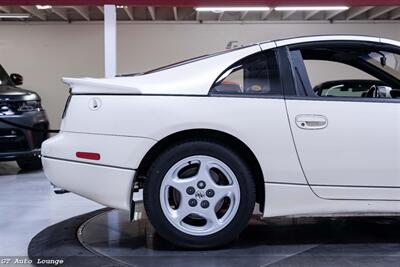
left=135, top=129, right=265, bottom=211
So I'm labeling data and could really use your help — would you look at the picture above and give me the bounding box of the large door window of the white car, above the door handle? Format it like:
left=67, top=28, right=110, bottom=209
left=290, top=46, right=400, bottom=98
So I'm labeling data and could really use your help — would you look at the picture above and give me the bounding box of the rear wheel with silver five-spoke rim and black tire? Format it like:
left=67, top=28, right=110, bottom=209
left=143, top=141, right=256, bottom=248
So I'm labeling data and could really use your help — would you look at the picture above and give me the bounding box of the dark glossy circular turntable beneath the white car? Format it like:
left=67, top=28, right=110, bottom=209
left=29, top=203, right=400, bottom=267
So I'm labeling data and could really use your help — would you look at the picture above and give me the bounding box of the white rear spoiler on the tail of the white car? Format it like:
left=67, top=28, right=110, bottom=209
left=62, top=78, right=142, bottom=94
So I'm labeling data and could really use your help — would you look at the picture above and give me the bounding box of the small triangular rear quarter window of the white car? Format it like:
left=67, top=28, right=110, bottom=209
left=210, top=51, right=282, bottom=95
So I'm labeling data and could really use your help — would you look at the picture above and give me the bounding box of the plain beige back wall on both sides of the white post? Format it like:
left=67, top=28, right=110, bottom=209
left=0, top=23, right=400, bottom=128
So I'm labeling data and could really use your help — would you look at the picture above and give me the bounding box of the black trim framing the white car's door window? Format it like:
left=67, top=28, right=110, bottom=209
left=283, top=40, right=400, bottom=104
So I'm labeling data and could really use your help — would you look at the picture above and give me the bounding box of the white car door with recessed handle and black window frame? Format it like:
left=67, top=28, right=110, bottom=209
left=286, top=42, right=400, bottom=200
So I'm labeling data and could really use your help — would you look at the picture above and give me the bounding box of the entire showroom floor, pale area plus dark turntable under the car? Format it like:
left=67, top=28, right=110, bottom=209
left=0, top=163, right=400, bottom=266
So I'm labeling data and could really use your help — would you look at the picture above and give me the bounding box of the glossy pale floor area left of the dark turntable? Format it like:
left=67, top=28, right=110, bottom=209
left=0, top=162, right=102, bottom=256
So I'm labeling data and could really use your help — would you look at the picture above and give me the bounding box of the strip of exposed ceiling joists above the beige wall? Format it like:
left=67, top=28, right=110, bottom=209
left=0, top=4, right=400, bottom=22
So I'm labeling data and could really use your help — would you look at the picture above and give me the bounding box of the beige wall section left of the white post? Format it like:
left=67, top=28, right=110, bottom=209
left=0, top=24, right=104, bottom=128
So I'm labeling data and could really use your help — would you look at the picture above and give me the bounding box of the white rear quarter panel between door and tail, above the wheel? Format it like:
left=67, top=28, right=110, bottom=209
left=62, top=95, right=306, bottom=184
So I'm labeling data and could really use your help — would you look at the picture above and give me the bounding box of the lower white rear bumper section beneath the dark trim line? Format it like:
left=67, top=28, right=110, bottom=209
left=42, top=156, right=135, bottom=211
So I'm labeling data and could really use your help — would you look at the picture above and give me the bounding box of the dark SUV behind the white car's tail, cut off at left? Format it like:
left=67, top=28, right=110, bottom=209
left=0, top=65, right=49, bottom=170
